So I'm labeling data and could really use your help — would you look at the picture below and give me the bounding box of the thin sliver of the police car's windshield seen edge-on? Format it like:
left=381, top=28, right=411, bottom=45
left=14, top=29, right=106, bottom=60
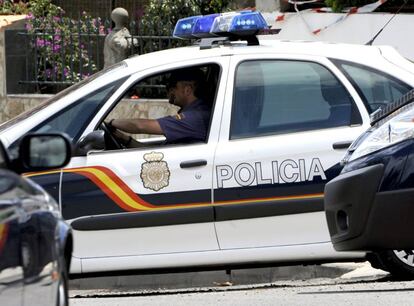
left=0, top=62, right=127, bottom=132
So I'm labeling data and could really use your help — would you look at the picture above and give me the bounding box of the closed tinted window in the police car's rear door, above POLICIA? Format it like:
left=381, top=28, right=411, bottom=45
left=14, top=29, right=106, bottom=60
left=230, top=60, right=361, bottom=139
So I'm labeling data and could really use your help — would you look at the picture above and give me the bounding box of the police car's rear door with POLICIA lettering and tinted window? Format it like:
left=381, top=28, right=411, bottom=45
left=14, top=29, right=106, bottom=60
left=213, top=55, right=368, bottom=253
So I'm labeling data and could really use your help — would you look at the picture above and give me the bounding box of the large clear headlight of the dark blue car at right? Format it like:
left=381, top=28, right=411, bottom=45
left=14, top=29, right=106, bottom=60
left=348, top=103, right=414, bottom=161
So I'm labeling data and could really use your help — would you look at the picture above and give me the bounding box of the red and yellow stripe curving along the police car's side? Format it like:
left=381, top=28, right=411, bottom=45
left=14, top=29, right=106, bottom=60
left=26, top=166, right=323, bottom=211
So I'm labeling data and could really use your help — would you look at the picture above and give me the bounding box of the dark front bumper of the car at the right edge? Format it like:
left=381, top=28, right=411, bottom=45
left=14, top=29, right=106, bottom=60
left=325, top=164, right=414, bottom=251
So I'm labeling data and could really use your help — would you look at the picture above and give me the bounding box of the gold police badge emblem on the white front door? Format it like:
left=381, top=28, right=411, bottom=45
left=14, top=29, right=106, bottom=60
left=141, top=152, right=170, bottom=191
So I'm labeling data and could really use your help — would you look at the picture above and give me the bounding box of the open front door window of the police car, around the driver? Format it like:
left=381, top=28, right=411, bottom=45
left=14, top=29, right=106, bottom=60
left=104, top=63, right=221, bottom=150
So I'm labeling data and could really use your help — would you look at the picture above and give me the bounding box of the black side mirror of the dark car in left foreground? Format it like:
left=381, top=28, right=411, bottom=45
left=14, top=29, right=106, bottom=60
left=18, top=133, right=72, bottom=171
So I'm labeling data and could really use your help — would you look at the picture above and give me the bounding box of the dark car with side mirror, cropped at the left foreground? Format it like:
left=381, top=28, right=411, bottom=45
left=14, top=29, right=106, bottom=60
left=0, top=134, right=72, bottom=306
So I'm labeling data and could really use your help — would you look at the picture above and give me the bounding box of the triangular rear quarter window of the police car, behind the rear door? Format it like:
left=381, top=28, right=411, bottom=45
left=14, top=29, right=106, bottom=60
left=333, top=60, right=412, bottom=113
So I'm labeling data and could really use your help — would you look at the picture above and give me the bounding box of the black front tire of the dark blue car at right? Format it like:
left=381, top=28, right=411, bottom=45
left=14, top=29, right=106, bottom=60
left=368, top=250, right=414, bottom=279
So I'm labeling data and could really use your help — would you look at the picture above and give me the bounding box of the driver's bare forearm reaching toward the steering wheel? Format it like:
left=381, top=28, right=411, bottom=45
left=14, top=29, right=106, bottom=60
left=110, top=119, right=163, bottom=135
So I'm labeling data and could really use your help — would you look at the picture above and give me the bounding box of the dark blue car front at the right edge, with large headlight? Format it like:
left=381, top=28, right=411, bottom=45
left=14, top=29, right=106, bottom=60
left=325, top=90, right=414, bottom=277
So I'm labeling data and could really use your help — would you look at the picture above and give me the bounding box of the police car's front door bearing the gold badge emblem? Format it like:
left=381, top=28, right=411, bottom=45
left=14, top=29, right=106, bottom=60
left=61, top=58, right=229, bottom=272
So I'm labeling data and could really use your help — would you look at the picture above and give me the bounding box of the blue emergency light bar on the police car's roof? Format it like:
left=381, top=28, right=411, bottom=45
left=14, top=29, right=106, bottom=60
left=173, top=11, right=269, bottom=39
